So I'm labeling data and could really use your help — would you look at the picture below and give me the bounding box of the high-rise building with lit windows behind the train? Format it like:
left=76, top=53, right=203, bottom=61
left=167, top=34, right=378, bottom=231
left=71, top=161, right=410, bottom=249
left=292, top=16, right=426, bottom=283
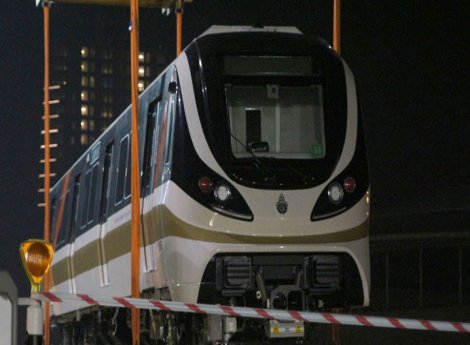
left=40, top=41, right=173, bottom=187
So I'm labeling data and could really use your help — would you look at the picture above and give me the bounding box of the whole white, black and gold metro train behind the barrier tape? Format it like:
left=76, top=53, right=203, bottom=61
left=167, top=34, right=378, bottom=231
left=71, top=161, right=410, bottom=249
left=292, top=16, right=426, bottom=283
left=50, top=26, right=370, bottom=344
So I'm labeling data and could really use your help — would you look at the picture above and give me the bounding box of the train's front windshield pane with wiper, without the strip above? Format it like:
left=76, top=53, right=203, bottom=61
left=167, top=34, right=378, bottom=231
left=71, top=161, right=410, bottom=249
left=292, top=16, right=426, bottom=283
left=225, top=84, right=325, bottom=159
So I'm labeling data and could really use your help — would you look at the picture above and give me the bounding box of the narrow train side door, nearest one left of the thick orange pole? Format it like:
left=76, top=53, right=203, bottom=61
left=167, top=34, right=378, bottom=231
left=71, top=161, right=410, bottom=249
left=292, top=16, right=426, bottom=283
left=98, top=141, right=114, bottom=286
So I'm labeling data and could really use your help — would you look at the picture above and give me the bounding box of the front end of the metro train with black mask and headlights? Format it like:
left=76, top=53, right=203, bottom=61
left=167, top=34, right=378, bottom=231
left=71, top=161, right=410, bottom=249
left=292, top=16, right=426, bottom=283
left=163, top=28, right=370, bottom=310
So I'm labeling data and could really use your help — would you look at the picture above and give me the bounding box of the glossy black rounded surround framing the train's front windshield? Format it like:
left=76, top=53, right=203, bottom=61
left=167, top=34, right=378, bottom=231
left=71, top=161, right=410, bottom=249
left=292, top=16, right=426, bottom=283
left=186, top=33, right=347, bottom=189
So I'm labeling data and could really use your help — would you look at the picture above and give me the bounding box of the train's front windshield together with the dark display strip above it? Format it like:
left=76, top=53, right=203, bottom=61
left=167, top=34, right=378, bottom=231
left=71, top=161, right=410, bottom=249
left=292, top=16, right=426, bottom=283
left=224, top=56, right=325, bottom=159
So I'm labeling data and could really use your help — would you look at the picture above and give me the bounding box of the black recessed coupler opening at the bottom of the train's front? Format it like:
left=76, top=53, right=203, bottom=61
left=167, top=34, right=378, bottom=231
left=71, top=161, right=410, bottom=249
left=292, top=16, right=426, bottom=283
left=198, top=253, right=364, bottom=310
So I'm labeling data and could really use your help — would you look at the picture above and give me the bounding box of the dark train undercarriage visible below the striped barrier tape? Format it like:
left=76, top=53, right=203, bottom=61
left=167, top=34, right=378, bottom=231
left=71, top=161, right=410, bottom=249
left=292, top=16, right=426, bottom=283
left=51, top=308, right=327, bottom=345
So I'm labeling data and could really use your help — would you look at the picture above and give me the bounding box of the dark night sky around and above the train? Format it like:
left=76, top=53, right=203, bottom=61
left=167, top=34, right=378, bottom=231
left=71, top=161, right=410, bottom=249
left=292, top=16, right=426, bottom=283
left=0, top=0, right=470, bottom=338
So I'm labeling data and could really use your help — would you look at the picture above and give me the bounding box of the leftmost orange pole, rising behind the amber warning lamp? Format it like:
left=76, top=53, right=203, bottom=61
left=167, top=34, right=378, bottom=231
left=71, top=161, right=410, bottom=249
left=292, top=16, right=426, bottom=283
left=43, top=1, right=51, bottom=345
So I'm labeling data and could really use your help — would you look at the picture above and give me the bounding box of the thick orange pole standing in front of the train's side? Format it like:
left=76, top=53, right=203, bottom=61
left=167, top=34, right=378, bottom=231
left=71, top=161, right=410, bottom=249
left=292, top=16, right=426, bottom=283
left=130, top=0, right=140, bottom=345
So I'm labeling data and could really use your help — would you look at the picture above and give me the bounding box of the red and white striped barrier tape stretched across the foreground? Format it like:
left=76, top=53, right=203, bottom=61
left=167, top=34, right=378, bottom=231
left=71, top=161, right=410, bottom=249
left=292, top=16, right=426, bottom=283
left=32, top=292, right=470, bottom=333
